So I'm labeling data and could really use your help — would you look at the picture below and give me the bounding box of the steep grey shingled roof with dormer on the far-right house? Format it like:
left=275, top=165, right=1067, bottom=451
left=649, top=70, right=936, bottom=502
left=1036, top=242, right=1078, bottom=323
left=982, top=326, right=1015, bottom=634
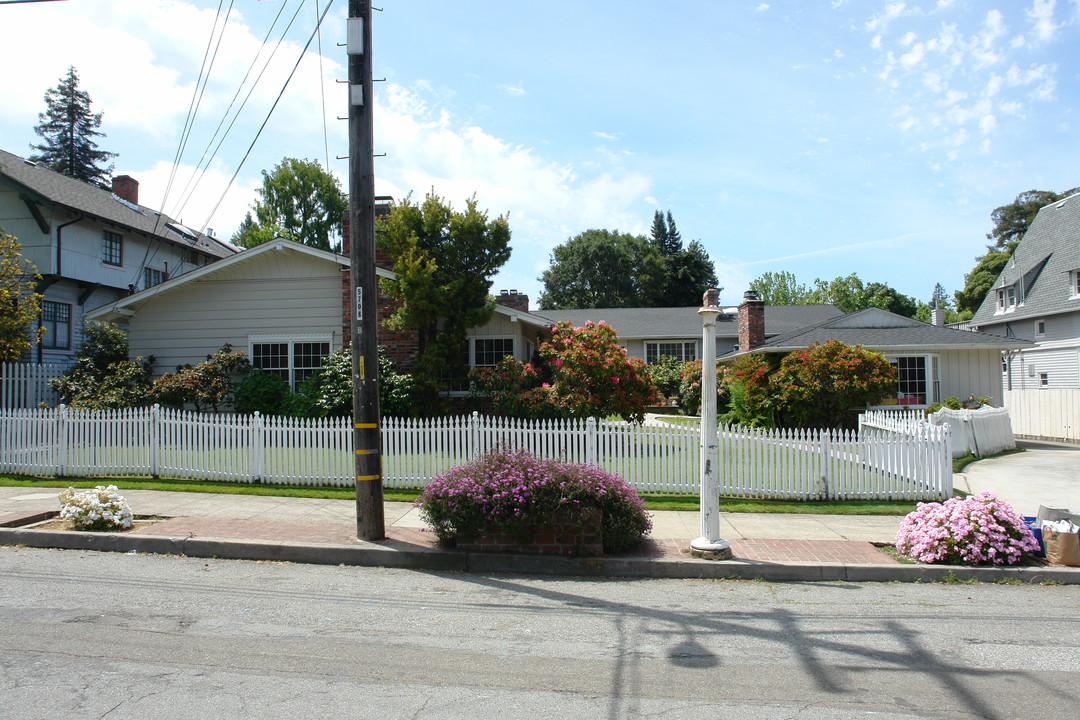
left=969, top=193, right=1080, bottom=326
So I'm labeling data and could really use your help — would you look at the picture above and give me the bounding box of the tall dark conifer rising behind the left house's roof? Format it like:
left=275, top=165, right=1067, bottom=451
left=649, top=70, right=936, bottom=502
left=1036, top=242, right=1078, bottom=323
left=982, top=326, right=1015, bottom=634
left=29, top=66, right=117, bottom=188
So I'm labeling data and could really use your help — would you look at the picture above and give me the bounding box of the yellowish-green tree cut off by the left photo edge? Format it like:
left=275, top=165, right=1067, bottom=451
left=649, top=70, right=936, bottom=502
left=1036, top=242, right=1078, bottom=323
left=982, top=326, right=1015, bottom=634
left=0, top=228, right=45, bottom=363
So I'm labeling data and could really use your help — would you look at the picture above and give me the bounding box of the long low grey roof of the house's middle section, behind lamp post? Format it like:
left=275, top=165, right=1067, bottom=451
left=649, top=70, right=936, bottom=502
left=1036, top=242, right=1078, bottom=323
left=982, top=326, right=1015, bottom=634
left=531, top=305, right=843, bottom=340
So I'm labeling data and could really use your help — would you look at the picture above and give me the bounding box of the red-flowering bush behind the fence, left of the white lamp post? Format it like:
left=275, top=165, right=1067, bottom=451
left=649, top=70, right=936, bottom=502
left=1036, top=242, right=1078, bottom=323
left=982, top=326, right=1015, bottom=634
left=470, top=322, right=657, bottom=422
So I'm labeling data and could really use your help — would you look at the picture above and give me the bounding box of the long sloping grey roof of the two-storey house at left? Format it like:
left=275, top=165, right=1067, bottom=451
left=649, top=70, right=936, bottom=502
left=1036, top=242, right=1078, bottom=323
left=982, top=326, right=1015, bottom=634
left=0, top=145, right=239, bottom=258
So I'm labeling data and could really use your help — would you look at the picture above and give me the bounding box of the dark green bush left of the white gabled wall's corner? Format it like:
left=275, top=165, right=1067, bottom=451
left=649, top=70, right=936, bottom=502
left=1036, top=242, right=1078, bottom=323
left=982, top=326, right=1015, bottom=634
left=52, top=323, right=153, bottom=410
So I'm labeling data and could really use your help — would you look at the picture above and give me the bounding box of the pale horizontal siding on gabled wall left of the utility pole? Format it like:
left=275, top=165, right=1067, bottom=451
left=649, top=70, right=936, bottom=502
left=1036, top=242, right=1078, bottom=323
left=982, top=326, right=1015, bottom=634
left=129, top=253, right=341, bottom=375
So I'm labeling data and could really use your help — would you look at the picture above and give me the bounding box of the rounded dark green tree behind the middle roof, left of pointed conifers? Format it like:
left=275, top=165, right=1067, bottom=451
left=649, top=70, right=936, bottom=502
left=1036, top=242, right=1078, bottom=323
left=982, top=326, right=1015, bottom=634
left=539, top=230, right=660, bottom=310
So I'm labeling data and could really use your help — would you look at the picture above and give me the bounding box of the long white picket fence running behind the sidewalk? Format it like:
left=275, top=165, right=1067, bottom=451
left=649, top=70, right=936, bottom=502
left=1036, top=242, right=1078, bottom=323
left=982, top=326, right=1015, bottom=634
left=0, top=407, right=951, bottom=500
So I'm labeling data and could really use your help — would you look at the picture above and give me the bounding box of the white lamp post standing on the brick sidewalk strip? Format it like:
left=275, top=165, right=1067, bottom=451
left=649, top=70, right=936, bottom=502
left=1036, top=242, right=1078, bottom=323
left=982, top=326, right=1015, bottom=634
left=690, top=287, right=731, bottom=560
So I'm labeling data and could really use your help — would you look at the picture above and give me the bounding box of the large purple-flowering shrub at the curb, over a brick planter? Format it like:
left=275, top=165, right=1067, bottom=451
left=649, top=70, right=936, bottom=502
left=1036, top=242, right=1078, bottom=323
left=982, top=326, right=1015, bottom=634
left=416, top=448, right=652, bottom=552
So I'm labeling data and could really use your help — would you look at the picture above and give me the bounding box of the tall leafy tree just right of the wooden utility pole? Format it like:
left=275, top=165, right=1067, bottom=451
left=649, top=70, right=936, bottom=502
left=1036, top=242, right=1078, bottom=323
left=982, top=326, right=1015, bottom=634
left=376, top=190, right=510, bottom=409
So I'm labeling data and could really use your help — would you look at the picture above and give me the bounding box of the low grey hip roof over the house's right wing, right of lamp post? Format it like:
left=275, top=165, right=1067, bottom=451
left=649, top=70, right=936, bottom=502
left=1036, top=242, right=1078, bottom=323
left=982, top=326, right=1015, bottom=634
left=724, top=308, right=1035, bottom=358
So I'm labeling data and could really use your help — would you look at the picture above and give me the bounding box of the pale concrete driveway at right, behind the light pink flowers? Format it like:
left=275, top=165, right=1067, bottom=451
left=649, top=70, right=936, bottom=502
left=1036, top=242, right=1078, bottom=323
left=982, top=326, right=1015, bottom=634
left=953, top=440, right=1080, bottom=515
